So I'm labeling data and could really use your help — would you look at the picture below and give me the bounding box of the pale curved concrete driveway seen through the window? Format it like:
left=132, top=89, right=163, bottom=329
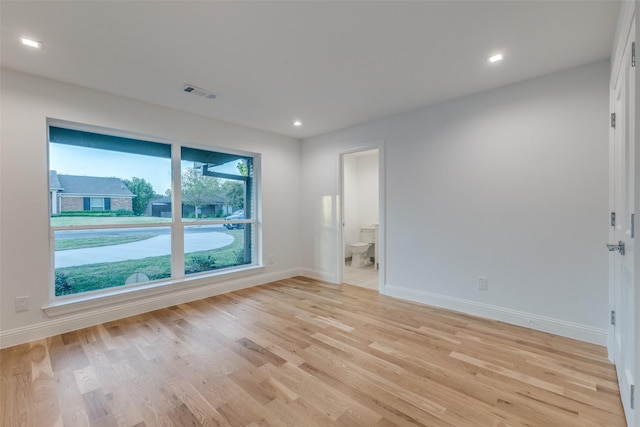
left=55, top=231, right=234, bottom=268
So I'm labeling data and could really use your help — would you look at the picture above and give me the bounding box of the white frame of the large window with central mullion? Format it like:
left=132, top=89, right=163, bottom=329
left=43, top=118, right=264, bottom=306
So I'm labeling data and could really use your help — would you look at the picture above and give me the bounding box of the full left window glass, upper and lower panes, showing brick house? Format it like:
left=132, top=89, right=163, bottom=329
left=49, top=126, right=171, bottom=296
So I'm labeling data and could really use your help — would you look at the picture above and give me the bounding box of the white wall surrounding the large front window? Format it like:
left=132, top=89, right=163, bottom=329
left=0, top=69, right=301, bottom=347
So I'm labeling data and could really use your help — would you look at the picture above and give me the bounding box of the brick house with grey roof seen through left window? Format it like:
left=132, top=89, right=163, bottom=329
left=49, top=171, right=135, bottom=214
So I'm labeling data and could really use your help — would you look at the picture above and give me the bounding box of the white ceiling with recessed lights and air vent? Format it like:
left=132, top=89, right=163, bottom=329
left=0, top=0, right=619, bottom=138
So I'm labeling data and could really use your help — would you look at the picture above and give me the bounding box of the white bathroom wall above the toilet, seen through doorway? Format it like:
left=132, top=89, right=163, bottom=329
left=343, top=150, right=379, bottom=258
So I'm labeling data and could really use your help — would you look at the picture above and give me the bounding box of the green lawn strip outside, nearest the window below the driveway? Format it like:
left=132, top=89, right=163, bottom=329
left=56, top=230, right=244, bottom=296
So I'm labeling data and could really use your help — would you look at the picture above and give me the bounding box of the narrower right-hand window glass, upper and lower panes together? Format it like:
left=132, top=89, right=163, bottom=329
left=181, top=147, right=254, bottom=274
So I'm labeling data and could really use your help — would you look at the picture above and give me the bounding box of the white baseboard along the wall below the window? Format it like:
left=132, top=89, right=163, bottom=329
left=0, top=268, right=300, bottom=348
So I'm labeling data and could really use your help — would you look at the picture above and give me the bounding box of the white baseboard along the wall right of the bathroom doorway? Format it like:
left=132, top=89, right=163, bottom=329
left=384, top=285, right=608, bottom=346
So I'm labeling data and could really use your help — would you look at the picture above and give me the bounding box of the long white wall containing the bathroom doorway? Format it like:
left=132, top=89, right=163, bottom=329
left=302, top=62, right=609, bottom=344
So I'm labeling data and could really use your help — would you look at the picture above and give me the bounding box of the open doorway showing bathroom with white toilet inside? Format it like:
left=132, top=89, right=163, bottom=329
left=339, top=148, right=383, bottom=291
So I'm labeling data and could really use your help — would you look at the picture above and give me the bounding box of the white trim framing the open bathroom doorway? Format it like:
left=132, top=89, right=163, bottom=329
left=336, top=138, right=387, bottom=294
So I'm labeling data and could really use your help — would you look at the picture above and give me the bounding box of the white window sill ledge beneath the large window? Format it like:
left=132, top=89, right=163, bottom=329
left=42, top=265, right=265, bottom=317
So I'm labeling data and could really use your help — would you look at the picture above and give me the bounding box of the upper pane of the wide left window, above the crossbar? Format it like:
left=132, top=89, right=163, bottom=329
left=49, top=126, right=171, bottom=226
